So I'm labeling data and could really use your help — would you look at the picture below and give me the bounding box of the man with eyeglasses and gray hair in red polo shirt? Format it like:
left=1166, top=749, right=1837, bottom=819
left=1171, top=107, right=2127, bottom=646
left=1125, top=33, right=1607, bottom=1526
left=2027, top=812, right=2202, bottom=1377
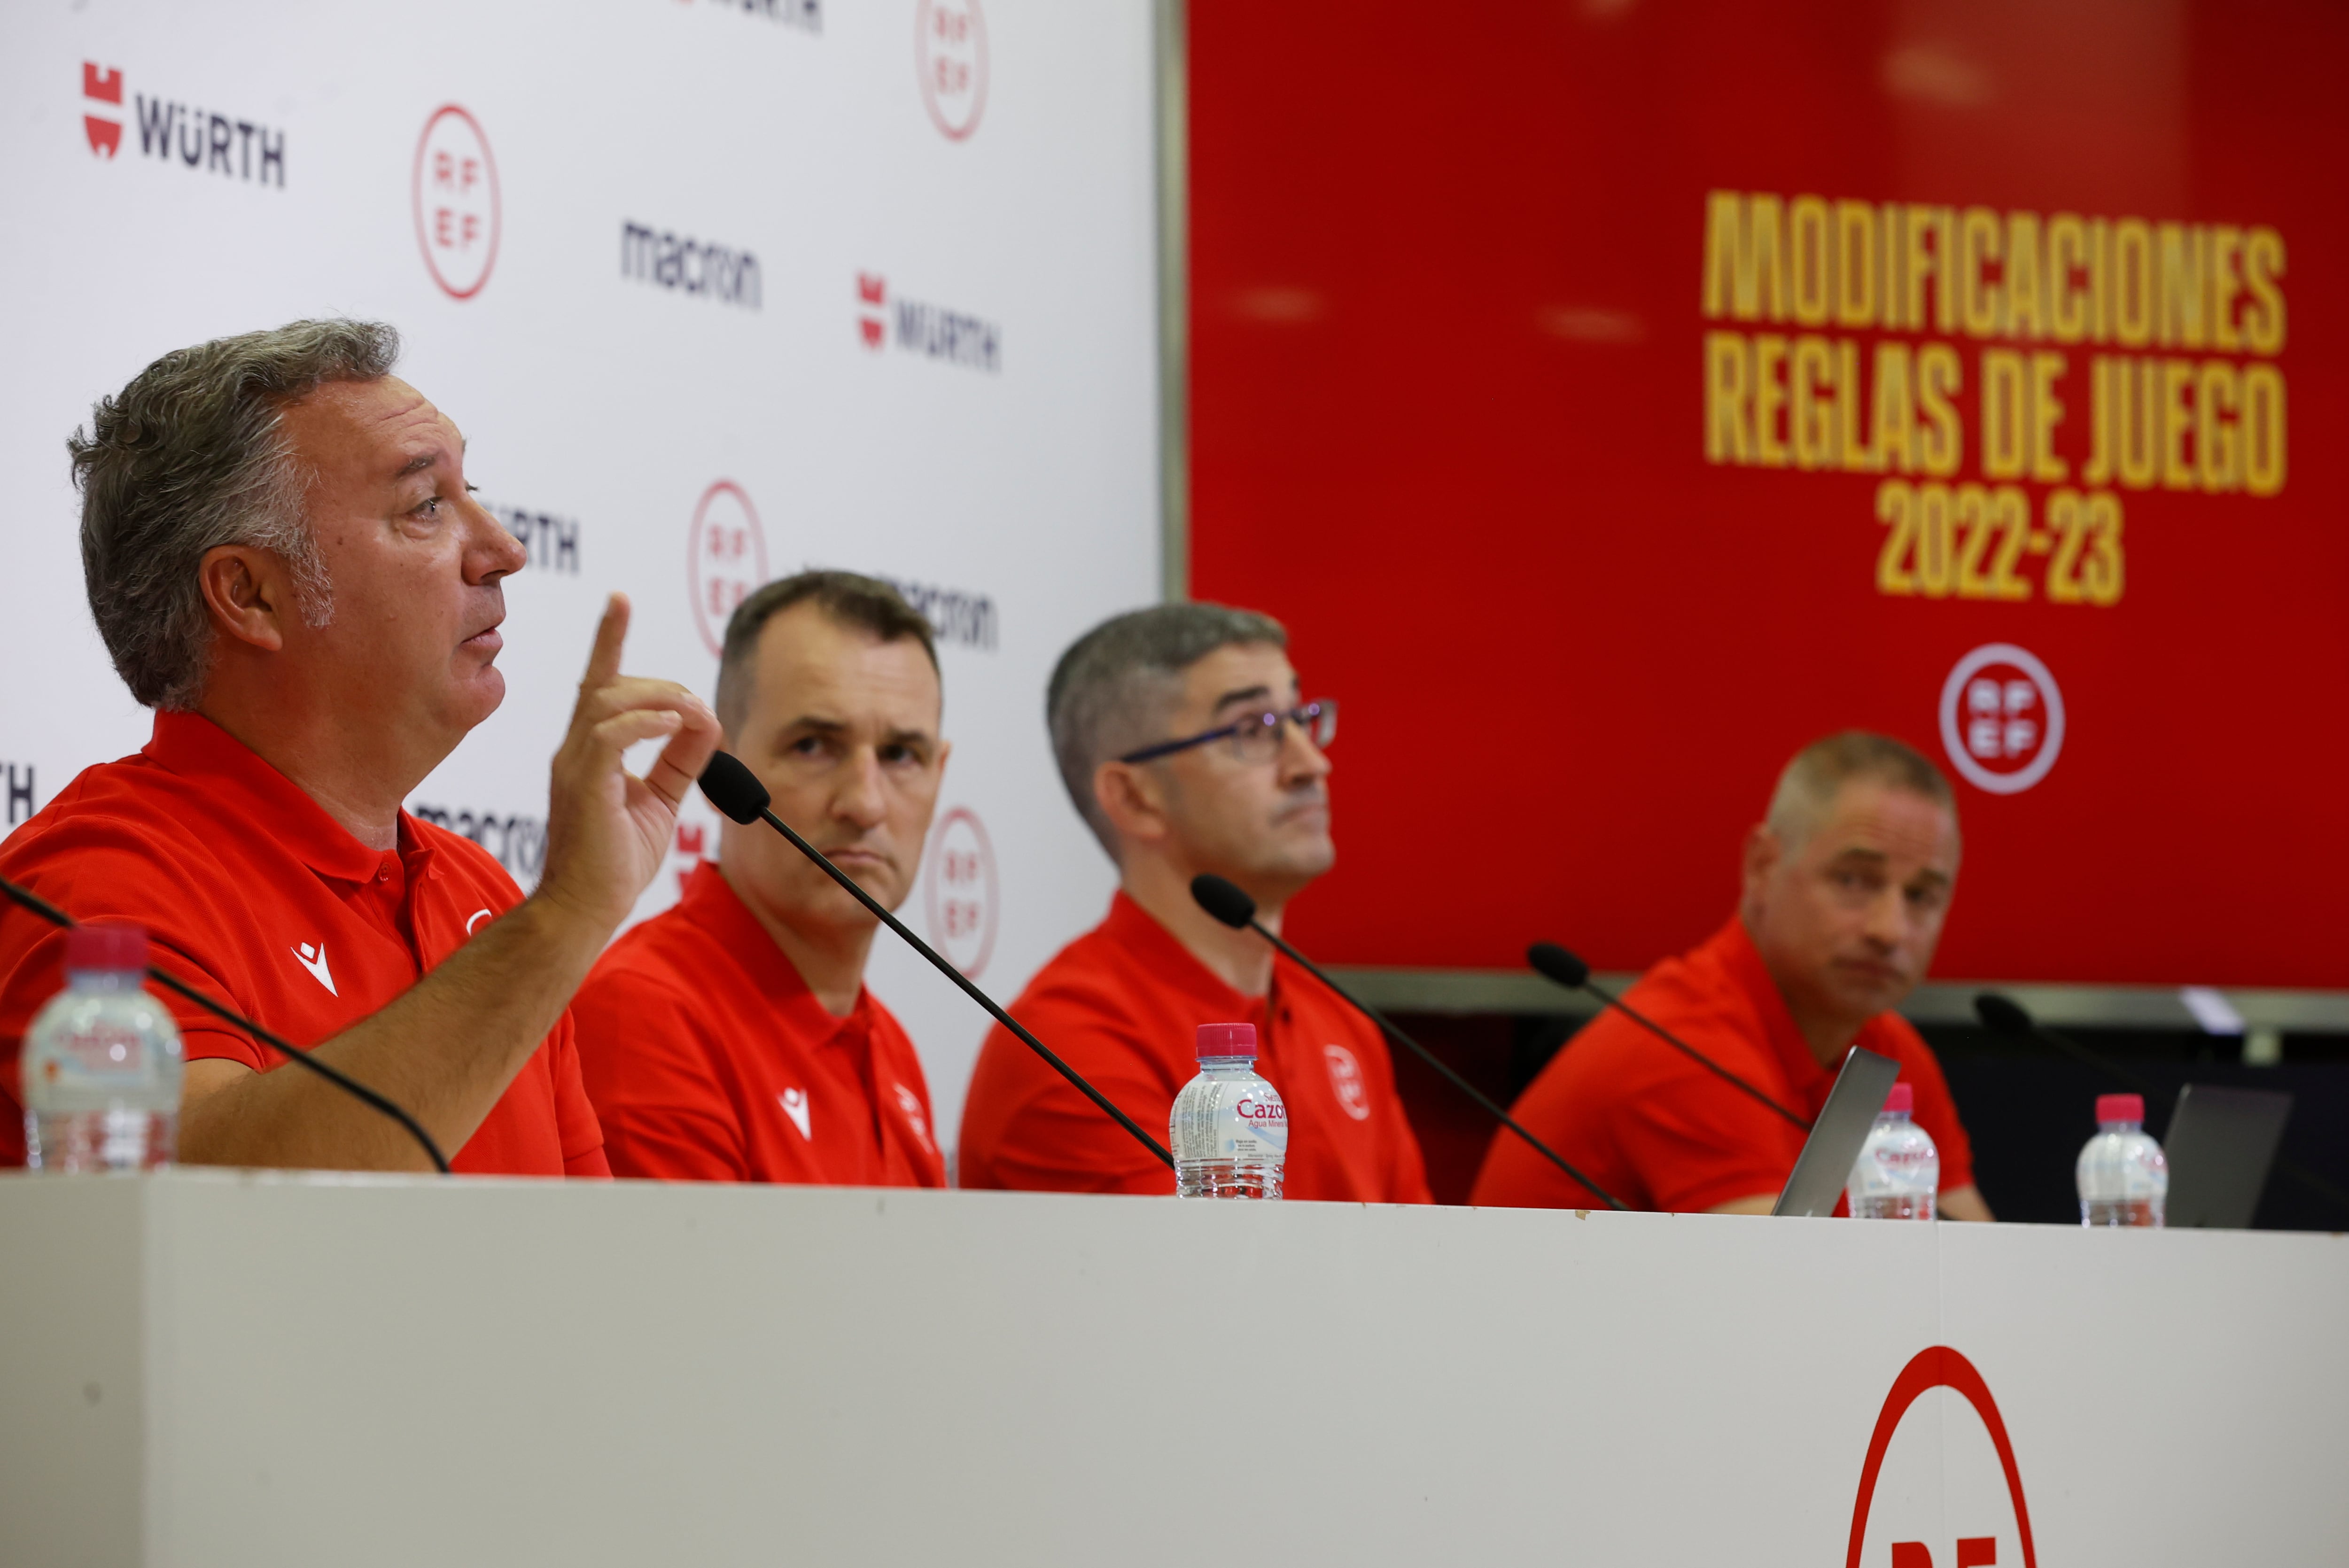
left=958, top=603, right=1428, bottom=1204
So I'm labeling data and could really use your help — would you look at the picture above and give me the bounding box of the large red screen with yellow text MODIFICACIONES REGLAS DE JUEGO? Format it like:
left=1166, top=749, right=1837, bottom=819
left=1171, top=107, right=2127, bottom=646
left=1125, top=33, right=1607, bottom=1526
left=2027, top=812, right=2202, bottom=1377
left=1191, top=0, right=2349, bottom=986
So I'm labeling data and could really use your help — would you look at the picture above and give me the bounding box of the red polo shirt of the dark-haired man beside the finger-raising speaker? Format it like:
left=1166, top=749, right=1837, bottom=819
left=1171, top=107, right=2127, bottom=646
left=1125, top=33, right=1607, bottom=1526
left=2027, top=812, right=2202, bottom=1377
left=571, top=864, right=947, bottom=1188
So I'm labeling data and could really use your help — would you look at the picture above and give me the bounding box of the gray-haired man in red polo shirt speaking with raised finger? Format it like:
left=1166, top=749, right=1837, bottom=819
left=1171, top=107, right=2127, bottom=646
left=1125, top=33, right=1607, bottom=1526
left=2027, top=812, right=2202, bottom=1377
left=0, top=322, right=719, bottom=1176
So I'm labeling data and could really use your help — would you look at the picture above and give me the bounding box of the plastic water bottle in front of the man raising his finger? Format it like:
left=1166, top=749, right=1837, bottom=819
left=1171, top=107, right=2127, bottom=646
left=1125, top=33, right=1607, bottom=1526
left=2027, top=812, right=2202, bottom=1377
left=23, top=925, right=181, bottom=1172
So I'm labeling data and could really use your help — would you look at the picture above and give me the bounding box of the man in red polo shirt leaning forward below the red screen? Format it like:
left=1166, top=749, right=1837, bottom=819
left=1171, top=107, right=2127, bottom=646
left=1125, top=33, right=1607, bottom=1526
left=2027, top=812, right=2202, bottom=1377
left=1468, top=730, right=1990, bottom=1220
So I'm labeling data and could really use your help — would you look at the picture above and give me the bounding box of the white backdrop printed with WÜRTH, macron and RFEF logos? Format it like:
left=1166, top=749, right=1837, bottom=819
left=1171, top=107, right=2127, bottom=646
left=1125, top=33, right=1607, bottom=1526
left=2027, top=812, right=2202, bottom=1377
left=0, top=0, right=1158, bottom=1150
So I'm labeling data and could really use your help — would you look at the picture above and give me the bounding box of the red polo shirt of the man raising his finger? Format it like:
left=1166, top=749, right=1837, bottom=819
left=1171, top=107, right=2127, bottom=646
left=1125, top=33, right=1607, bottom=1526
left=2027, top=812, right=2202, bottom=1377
left=0, top=714, right=608, bottom=1176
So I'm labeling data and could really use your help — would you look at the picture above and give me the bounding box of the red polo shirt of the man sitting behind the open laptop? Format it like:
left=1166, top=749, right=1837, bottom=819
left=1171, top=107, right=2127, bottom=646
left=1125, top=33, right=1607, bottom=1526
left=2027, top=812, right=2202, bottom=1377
left=1468, top=918, right=1973, bottom=1213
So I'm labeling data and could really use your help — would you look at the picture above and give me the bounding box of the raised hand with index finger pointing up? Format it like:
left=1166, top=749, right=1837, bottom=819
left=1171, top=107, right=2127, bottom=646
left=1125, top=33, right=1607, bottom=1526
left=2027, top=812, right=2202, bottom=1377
left=533, top=594, right=719, bottom=941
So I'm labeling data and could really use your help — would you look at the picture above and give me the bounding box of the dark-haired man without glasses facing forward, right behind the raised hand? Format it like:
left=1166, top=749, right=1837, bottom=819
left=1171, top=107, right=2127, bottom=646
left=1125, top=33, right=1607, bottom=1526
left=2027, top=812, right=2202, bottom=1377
left=571, top=570, right=949, bottom=1188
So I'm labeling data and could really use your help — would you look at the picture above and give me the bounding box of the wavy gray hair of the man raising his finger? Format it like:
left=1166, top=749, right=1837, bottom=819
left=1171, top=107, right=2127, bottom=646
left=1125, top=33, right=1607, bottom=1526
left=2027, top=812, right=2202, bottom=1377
left=66, top=322, right=399, bottom=709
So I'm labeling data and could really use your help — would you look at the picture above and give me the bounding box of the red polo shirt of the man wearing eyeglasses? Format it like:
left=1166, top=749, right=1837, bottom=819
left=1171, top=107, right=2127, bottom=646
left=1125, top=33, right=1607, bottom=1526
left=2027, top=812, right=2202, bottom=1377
left=958, top=892, right=1431, bottom=1204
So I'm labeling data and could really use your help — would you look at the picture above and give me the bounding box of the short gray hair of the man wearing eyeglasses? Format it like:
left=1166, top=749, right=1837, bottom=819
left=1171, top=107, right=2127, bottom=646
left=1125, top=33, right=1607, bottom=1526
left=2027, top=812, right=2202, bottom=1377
left=1043, top=603, right=1290, bottom=859
